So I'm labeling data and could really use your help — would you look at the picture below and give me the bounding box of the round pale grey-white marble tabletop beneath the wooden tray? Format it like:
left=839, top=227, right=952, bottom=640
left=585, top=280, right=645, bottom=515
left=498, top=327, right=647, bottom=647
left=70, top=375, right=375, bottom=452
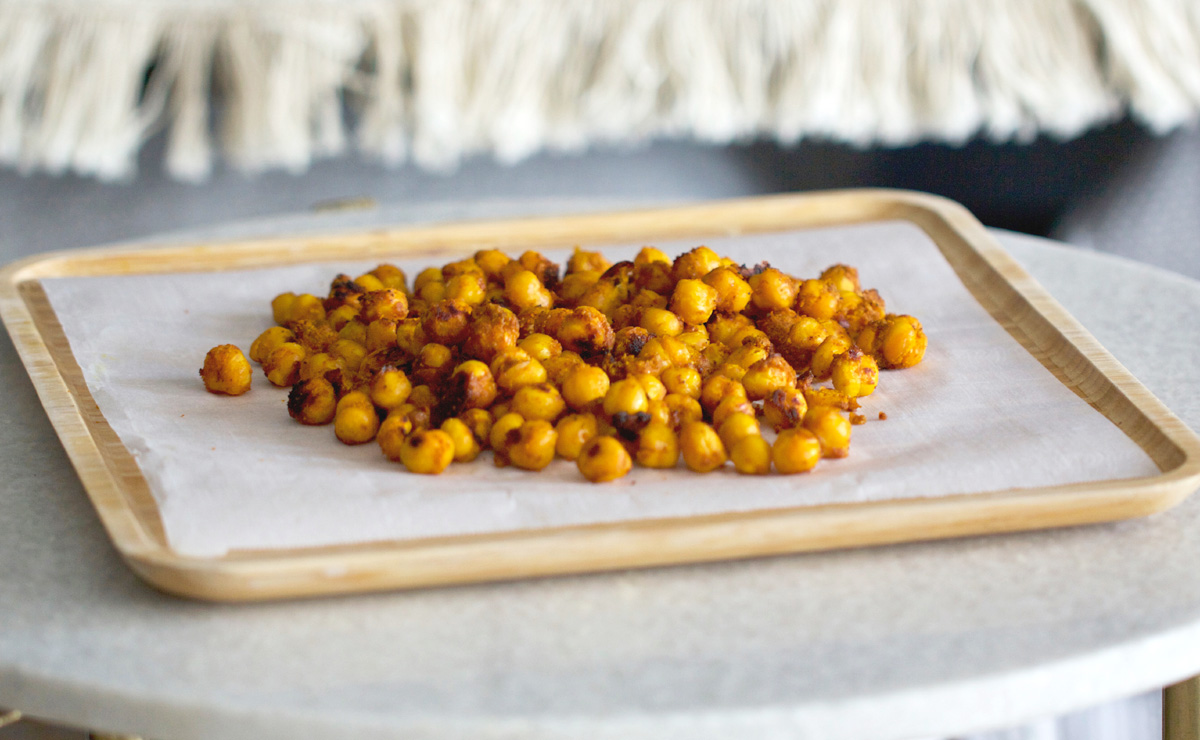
left=0, top=201, right=1200, bottom=740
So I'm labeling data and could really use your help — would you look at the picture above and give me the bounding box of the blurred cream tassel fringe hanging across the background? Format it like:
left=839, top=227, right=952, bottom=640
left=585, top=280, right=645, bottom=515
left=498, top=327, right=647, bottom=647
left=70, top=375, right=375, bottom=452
left=0, top=0, right=1200, bottom=180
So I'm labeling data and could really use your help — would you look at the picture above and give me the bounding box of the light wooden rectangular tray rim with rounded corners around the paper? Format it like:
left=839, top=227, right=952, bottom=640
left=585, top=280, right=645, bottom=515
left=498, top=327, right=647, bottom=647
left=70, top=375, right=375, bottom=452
left=0, top=191, right=1200, bottom=601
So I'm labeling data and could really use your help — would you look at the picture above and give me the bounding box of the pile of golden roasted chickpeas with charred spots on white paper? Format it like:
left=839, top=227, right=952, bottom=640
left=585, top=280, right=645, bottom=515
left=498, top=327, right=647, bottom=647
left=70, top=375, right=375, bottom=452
left=200, top=246, right=926, bottom=481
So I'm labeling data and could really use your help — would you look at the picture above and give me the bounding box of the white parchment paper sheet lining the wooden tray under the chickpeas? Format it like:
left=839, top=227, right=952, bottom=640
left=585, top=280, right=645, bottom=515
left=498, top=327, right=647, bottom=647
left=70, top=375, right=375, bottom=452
left=44, top=222, right=1158, bottom=556
